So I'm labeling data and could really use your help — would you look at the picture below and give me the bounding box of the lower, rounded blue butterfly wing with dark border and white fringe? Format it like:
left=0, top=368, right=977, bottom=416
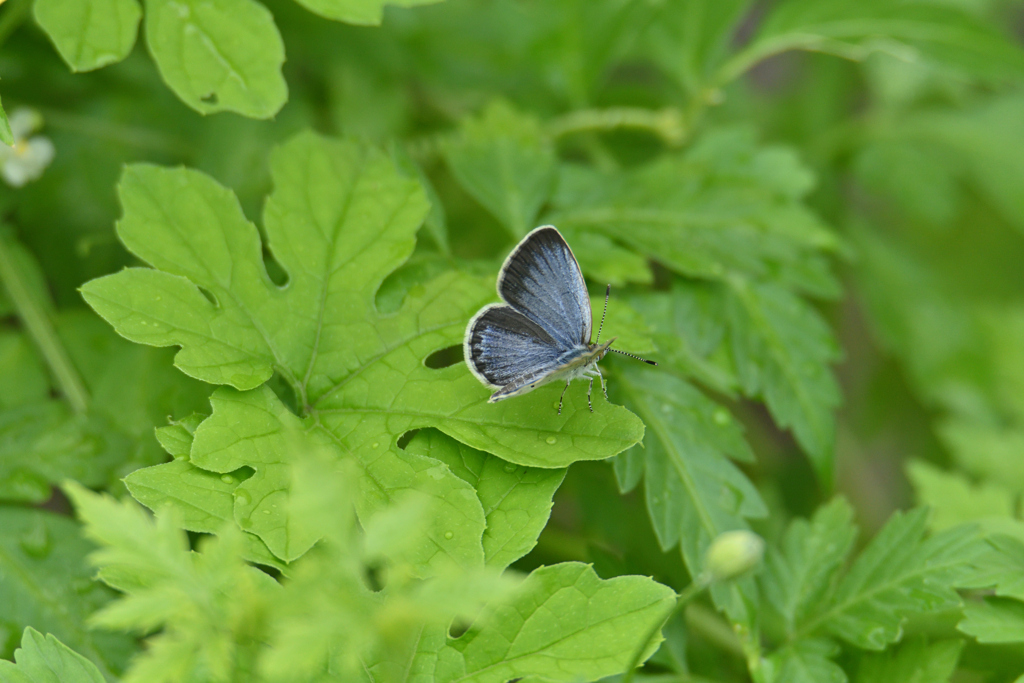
left=463, top=303, right=565, bottom=387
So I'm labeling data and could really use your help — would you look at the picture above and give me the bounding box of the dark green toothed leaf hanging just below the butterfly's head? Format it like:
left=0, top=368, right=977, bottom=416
left=611, top=361, right=767, bottom=575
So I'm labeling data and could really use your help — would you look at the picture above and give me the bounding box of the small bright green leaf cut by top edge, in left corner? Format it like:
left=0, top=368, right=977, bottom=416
left=34, top=0, right=142, bottom=71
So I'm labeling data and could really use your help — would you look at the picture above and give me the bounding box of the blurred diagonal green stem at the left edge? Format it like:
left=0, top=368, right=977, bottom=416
left=0, top=230, right=89, bottom=414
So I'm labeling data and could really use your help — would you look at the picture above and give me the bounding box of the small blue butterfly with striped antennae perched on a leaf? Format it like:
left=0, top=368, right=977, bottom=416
left=463, top=225, right=657, bottom=415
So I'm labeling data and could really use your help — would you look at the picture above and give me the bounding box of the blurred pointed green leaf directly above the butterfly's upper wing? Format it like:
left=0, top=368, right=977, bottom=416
left=444, top=101, right=556, bottom=240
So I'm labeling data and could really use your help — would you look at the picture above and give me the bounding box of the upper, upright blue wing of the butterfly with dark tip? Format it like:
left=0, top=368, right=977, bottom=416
left=498, top=225, right=593, bottom=351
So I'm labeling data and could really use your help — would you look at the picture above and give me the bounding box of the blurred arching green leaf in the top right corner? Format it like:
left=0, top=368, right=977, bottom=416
left=717, top=0, right=1024, bottom=84
